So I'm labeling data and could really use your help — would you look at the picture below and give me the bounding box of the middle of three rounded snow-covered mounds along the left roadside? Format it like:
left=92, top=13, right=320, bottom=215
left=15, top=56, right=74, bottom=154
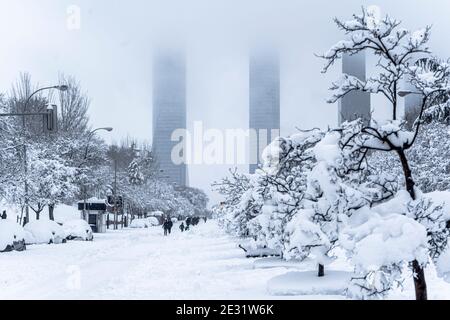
left=25, top=220, right=66, bottom=244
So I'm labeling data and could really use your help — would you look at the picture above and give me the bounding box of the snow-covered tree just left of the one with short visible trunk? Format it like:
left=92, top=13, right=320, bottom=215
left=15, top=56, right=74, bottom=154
left=251, top=130, right=323, bottom=259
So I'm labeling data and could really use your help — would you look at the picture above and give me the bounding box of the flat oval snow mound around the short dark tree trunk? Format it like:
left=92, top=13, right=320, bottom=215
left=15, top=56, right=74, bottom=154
left=267, top=271, right=352, bottom=296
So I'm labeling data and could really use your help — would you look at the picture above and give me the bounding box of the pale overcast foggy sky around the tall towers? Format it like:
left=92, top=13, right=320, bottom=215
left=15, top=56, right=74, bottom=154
left=0, top=0, right=450, bottom=202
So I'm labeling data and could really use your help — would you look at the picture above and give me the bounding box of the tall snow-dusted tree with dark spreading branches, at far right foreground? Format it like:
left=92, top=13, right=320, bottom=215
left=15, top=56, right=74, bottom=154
left=321, top=8, right=450, bottom=300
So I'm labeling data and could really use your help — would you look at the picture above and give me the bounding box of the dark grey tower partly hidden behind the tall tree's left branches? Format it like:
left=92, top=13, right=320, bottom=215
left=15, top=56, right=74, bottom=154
left=338, top=52, right=371, bottom=125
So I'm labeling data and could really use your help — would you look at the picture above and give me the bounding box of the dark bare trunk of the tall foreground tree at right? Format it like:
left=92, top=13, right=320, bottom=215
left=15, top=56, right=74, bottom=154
left=397, top=150, right=427, bottom=300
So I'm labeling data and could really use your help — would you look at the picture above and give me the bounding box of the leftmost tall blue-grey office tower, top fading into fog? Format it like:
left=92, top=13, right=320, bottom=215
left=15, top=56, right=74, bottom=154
left=153, top=51, right=187, bottom=186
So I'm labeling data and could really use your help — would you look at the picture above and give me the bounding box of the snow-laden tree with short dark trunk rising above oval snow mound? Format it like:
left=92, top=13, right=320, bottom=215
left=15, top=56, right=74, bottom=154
left=287, top=125, right=372, bottom=277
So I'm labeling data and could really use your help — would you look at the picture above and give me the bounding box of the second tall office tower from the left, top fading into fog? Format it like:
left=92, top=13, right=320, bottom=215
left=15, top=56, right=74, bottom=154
left=249, top=51, right=280, bottom=173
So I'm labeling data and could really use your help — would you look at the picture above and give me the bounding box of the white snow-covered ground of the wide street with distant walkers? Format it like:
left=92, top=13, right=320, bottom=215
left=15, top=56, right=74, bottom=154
left=0, top=221, right=450, bottom=300
